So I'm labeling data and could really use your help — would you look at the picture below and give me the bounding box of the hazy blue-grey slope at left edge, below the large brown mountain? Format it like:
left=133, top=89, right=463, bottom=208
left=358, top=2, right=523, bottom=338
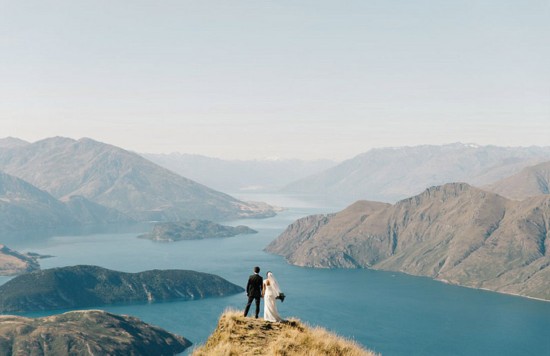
left=0, top=172, right=133, bottom=231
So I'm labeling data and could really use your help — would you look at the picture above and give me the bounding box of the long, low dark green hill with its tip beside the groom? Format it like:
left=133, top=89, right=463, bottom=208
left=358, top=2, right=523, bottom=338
left=0, top=266, right=244, bottom=313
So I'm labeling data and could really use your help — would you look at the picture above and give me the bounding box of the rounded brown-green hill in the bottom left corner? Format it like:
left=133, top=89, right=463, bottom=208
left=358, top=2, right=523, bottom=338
left=0, top=310, right=191, bottom=356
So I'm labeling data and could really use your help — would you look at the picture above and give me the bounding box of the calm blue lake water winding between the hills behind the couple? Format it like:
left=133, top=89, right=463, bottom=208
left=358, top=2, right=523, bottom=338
left=0, top=196, right=550, bottom=355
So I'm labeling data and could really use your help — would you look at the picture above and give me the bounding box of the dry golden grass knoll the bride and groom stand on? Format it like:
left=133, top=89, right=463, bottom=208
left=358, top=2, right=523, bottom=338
left=192, top=310, right=376, bottom=356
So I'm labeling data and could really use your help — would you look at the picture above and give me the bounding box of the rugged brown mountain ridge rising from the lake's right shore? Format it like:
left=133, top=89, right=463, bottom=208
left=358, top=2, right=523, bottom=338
left=266, top=183, right=550, bottom=300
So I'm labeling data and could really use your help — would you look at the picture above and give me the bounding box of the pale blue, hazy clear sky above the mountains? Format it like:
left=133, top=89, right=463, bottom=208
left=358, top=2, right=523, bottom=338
left=0, top=0, right=550, bottom=159
